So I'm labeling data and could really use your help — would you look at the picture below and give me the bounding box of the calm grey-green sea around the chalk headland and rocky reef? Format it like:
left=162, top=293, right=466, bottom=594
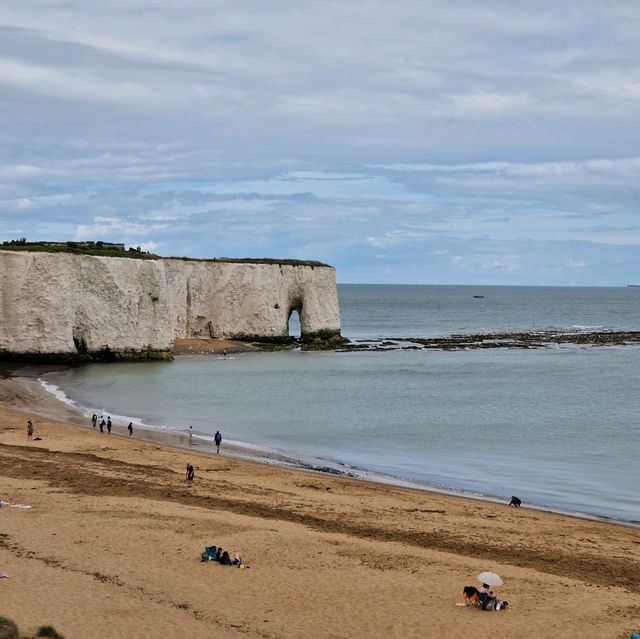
left=41, top=284, right=640, bottom=524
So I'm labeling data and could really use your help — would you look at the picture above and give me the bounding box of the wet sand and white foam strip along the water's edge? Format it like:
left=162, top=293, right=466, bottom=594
left=10, top=375, right=640, bottom=530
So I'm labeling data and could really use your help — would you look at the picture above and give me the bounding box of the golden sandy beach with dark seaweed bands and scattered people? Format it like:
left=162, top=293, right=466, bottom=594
left=0, top=379, right=640, bottom=639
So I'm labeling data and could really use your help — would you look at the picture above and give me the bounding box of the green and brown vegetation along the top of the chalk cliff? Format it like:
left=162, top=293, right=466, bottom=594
left=0, top=237, right=336, bottom=268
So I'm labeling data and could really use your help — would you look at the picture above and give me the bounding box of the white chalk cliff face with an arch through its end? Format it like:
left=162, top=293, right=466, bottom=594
left=0, top=251, right=340, bottom=359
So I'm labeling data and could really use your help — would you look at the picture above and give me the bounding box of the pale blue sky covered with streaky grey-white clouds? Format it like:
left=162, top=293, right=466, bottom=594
left=0, top=0, right=640, bottom=286
